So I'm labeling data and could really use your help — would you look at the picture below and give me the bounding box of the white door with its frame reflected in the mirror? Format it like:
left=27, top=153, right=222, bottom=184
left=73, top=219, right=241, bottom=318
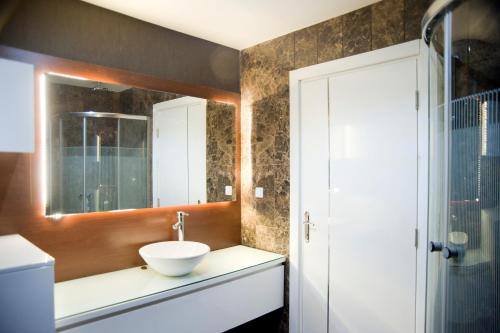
left=153, top=97, right=207, bottom=207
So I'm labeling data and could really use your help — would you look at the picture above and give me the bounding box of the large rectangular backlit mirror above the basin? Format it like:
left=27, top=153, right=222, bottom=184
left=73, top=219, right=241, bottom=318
left=45, top=74, right=236, bottom=215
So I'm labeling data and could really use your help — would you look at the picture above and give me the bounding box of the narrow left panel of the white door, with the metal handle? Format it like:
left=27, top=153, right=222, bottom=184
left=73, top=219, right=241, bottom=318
left=300, top=78, right=330, bottom=333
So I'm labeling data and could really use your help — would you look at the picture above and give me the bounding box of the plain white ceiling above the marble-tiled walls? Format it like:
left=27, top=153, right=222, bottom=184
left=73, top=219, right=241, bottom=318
left=84, top=0, right=379, bottom=50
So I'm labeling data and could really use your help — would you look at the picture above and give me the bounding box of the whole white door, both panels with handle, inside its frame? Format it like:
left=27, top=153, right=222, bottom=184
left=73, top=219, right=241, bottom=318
left=298, top=58, right=417, bottom=333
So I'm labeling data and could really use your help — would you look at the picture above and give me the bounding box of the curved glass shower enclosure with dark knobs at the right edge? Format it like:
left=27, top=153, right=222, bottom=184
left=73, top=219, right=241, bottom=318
left=423, top=0, right=500, bottom=333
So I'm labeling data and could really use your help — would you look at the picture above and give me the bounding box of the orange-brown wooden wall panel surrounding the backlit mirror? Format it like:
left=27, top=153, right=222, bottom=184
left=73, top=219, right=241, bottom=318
left=0, top=46, right=241, bottom=281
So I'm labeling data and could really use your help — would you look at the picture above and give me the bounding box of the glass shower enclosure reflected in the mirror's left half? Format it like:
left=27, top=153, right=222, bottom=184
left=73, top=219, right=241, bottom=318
left=47, top=111, right=151, bottom=215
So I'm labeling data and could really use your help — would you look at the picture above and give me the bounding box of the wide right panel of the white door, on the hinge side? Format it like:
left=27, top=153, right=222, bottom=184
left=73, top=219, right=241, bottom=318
left=330, top=59, right=417, bottom=333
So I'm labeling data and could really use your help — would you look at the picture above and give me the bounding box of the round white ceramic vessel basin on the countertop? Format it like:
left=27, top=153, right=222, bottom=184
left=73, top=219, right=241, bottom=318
left=139, top=241, right=210, bottom=276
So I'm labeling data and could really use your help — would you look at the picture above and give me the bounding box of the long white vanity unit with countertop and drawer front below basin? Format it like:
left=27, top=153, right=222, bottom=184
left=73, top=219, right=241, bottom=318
left=55, top=245, right=285, bottom=333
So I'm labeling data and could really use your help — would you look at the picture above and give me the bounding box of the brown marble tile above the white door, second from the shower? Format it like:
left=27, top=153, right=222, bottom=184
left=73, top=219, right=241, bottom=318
left=371, top=0, right=404, bottom=50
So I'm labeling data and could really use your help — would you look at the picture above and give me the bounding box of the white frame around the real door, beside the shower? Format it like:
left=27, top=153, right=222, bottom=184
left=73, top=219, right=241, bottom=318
left=289, top=40, right=428, bottom=333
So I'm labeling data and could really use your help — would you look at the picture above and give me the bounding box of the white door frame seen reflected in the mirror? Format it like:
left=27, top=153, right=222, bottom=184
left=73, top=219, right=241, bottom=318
left=151, top=96, right=207, bottom=208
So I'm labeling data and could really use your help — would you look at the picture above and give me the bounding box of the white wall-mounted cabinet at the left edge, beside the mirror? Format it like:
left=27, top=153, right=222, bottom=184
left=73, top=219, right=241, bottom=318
left=0, top=58, right=35, bottom=153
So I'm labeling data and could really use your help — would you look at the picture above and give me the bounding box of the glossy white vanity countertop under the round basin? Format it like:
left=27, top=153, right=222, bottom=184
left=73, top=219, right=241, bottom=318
left=55, top=245, right=285, bottom=327
